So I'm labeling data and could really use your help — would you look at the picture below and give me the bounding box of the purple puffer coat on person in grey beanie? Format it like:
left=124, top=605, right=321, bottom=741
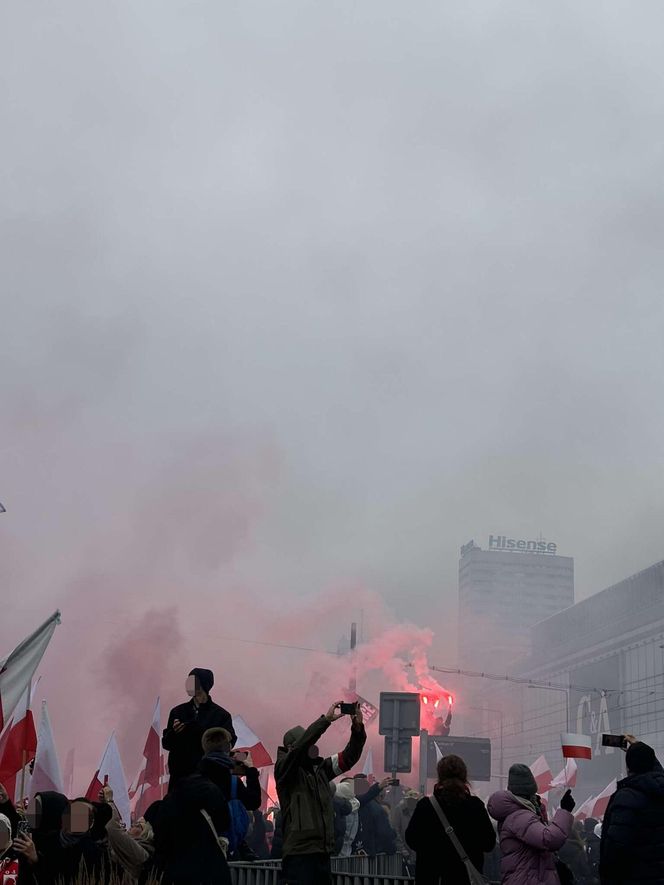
left=488, top=790, right=574, bottom=885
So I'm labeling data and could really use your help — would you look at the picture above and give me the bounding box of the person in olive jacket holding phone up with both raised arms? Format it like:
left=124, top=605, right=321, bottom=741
left=274, top=701, right=367, bottom=885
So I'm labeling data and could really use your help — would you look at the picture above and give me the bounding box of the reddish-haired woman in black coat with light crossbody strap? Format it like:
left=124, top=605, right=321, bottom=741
left=406, top=756, right=496, bottom=885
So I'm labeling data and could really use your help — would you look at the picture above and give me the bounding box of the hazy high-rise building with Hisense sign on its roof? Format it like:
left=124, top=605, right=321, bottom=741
left=459, top=535, right=574, bottom=672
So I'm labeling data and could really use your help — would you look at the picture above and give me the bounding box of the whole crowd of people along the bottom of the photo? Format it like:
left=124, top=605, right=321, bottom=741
left=0, top=668, right=664, bottom=885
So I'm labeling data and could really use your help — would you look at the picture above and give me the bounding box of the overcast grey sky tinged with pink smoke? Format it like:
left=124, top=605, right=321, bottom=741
left=0, top=0, right=664, bottom=772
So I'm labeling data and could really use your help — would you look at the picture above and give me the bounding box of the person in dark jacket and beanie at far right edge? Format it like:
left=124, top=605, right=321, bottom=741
left=599, top=735, right=664, bottom=885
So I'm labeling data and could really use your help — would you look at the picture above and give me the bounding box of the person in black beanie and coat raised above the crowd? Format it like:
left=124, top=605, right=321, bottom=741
left=161, top=667, right=237, bottom=792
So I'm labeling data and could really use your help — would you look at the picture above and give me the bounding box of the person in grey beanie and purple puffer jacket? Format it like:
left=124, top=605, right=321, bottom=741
left=488, top=765, right=575, bottom=885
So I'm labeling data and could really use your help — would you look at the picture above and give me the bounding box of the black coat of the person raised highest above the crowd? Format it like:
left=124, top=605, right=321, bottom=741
left=161, top=698, right=237, bottom=790
